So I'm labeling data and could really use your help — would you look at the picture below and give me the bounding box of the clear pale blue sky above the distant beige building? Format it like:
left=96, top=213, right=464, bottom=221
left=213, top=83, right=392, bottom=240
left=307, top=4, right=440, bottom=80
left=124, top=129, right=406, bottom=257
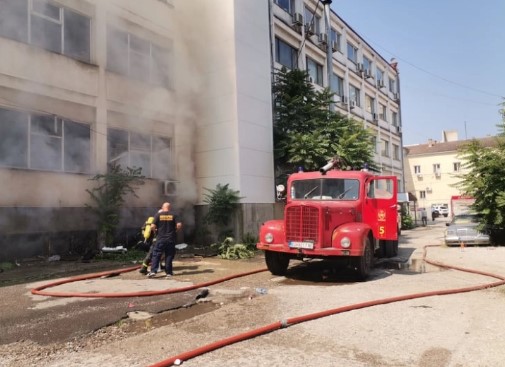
left=331, top=0, right=505, bottom=145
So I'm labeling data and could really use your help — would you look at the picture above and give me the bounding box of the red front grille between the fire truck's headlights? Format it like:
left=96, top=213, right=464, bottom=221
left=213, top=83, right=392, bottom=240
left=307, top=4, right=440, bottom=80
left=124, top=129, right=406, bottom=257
left=286, top=206, right=319, bottom=243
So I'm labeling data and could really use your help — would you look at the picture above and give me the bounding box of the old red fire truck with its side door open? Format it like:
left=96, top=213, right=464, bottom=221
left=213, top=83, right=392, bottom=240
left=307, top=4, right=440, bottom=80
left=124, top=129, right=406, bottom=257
left=257, top=162, right=398, bottom=280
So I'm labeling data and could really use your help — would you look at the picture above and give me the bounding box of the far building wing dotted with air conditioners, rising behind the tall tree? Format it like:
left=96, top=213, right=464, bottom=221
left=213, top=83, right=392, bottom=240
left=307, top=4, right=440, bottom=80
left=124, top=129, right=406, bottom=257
left=271, top=0, right=403, bottom=183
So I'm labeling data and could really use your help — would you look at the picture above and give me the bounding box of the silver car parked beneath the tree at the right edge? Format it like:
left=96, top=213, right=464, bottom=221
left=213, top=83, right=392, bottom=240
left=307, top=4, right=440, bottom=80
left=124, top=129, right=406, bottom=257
left=444, top=213, right=490, bottom=246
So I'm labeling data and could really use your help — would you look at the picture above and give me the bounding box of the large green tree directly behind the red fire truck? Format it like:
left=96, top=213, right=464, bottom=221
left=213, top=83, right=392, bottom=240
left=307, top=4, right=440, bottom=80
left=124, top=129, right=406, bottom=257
left=273, top=68, right=374, bottom=174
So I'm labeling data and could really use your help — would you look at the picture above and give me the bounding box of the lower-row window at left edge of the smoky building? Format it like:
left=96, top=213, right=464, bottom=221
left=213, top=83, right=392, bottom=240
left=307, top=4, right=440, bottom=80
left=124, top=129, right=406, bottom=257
left=0, top=109, right=91, bottom=173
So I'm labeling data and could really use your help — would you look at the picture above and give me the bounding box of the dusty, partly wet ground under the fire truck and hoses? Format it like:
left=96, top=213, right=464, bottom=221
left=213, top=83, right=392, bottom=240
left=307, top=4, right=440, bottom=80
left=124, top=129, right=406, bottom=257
left=0, top=220, right=505, bottom=367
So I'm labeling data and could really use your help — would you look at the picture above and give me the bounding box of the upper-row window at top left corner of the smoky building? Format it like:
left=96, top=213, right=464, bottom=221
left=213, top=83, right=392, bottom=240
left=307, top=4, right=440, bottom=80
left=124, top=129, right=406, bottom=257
left=0, top=0, right=91, bottom=62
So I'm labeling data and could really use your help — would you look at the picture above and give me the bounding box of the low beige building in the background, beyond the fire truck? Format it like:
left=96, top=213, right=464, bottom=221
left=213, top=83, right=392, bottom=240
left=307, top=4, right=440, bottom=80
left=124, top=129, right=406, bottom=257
left=404, top=131, right=495, bottom=217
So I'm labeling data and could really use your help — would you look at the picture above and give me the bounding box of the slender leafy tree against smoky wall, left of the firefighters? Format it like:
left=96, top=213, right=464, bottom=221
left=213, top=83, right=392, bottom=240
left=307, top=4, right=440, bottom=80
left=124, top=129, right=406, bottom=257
left=86, top=164, right=144, bottom=248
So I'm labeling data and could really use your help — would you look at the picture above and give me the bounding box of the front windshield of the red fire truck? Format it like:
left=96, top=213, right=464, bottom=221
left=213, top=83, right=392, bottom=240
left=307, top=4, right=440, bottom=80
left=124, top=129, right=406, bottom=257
left=291, top=178, right=359, bottom=200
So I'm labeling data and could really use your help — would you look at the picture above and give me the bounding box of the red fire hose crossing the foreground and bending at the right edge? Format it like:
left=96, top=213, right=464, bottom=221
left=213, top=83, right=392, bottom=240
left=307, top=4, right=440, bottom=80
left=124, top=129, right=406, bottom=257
left=149, top=246, right=505, bottom=367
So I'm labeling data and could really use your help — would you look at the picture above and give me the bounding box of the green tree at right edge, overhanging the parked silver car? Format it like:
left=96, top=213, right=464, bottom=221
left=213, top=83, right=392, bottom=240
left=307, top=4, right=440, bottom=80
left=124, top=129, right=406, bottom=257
left=456, top=102, right=505, bottom=242
